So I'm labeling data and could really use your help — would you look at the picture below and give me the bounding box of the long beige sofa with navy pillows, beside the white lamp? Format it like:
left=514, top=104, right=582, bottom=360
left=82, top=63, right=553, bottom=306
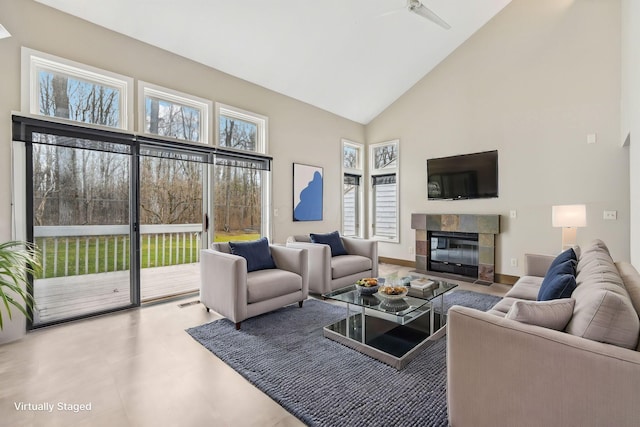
left=447, top=240, right=640, bottom=427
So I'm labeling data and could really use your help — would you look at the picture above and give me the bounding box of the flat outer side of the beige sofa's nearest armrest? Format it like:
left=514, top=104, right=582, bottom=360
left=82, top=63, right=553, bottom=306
left=447, top=306, right=640, bottom=427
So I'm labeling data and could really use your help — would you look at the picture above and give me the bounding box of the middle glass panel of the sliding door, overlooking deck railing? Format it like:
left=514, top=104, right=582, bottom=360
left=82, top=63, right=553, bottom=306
left=139, top=147, right=208, bottom=302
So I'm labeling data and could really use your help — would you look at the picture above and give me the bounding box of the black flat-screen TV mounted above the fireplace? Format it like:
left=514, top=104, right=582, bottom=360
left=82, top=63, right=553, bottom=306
left=427, top=150, right=498, bottom=200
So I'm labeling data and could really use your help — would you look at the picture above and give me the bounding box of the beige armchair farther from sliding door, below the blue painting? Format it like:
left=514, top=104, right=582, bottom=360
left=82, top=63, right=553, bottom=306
left=287, top=235, right=378, bottom=294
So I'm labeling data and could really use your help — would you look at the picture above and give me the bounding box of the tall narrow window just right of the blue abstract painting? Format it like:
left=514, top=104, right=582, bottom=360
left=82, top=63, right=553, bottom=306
left=342, top=139, right=364, bottom=237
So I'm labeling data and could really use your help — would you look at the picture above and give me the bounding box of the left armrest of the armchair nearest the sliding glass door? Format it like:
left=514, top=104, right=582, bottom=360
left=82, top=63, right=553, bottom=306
left=200, top=249, right=247, bottom=322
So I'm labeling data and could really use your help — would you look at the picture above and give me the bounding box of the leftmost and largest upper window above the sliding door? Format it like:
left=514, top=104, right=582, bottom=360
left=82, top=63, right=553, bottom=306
left=22, top=48, right=133, bottom=129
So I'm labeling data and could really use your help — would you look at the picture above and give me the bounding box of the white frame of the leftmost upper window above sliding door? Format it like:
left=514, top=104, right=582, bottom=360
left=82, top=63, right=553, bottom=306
left=21, top=47, right=134, bottom=131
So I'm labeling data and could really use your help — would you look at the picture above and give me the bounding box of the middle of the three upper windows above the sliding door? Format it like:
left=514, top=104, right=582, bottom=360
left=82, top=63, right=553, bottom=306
left=139, top=82, right=212, bottom=143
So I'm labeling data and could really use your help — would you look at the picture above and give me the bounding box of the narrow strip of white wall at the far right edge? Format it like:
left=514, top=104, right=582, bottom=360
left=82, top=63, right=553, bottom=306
left=621, top=0, right=640, bottom=268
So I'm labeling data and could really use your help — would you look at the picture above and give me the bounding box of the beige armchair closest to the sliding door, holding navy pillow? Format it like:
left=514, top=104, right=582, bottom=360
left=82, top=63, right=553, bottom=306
left=200, top=243, right=309, bottom=329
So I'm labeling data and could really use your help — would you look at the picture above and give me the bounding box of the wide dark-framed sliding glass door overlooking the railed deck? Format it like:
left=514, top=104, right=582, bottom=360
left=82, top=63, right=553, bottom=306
left=13, top=116, right=271, bottom=327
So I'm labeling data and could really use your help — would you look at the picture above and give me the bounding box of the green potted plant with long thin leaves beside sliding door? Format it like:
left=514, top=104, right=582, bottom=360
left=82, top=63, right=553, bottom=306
left=0, top=241, right=42, bottom=330
